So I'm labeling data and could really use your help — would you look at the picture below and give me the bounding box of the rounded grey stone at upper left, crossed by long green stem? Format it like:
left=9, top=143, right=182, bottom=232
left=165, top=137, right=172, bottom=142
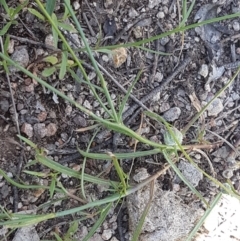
left=9, top=46, right=29, bottom=73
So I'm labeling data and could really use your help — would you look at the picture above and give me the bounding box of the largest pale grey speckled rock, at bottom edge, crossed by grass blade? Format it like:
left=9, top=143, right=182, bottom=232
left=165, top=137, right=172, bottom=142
left=127, top=183, right=202, bottom=241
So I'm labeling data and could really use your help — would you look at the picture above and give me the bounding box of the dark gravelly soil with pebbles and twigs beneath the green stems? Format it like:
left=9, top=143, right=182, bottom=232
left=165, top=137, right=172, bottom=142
left=0, top=0, right=240, bottom=241
